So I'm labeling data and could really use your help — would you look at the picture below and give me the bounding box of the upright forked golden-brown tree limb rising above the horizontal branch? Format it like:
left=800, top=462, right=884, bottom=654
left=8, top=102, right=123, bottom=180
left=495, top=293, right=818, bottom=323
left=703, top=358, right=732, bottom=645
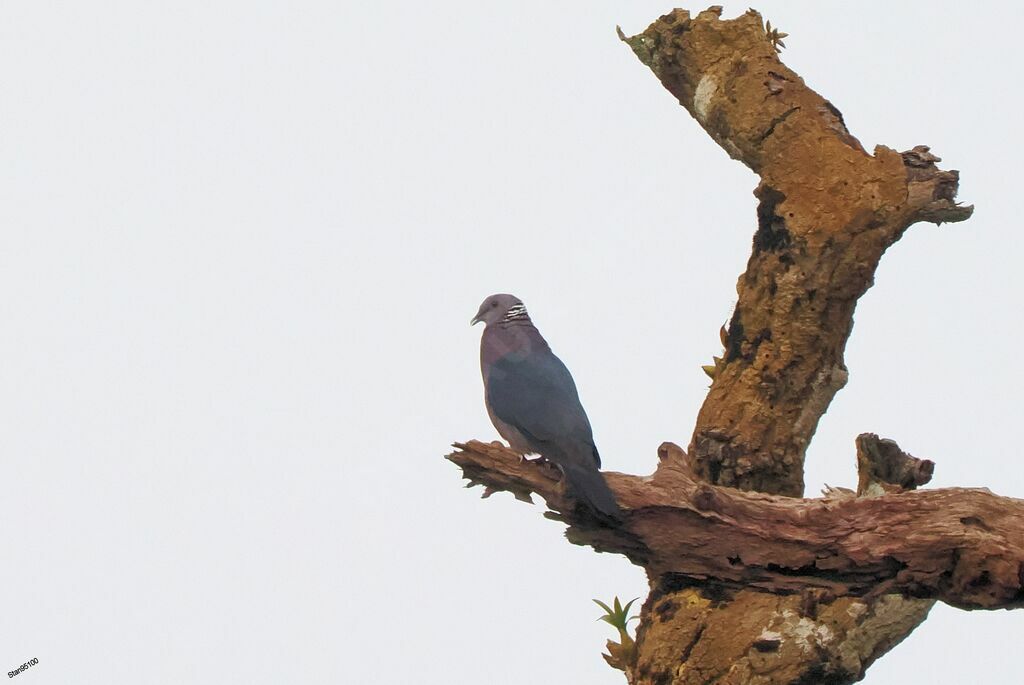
left=622, top=7, right=972, bottom=497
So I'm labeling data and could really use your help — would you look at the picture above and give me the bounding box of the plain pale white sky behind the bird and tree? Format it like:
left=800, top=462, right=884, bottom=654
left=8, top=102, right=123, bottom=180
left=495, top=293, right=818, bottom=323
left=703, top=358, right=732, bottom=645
left=0, top=0, right=1024, bottom=685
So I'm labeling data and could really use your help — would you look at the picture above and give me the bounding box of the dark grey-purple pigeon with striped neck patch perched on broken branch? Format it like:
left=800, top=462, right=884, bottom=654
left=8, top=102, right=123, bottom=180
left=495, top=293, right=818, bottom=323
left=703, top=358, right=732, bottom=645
left=471, top=294, right=622, bottom=520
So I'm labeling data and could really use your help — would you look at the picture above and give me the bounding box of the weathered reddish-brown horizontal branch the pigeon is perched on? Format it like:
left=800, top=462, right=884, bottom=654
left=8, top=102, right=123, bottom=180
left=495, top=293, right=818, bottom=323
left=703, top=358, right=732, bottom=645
left=449, top=440, right=1024, bottom=609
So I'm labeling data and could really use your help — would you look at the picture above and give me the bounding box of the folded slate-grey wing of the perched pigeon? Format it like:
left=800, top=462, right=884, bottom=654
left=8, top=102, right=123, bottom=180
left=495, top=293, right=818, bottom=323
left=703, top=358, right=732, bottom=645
left=487, top=352, right=600, bottom=466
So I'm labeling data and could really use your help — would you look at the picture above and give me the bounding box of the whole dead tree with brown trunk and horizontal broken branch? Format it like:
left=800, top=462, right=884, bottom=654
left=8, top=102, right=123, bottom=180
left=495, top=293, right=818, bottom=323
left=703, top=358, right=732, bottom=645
left=449, top=7, right=1024, bottom=685
